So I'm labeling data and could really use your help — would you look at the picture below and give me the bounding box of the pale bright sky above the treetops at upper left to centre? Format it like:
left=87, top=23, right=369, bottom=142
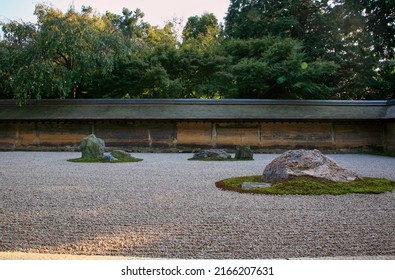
left=0, top=0, right=229, bottom=26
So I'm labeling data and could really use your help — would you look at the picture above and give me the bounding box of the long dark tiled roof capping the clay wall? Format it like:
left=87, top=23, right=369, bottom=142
left=0, top=99, right=395, bottom=121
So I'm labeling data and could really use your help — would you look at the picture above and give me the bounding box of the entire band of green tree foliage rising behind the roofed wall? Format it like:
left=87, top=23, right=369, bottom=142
left=0, top=0, right=395, bottom=103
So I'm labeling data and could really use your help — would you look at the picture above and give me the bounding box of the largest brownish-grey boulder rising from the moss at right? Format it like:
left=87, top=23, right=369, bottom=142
left=262, top=150, right=357, bottom=183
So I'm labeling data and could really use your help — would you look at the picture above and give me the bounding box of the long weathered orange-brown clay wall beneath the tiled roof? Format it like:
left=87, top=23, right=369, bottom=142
left=0, top=121, right=395, bottom=152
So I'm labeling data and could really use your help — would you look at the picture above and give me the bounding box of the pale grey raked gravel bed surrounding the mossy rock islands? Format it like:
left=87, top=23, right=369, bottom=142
left=0, top=152, right=395, bottom=259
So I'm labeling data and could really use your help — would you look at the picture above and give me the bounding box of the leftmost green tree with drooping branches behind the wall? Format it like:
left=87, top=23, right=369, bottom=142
left=3, top=5, right=129, bottom=102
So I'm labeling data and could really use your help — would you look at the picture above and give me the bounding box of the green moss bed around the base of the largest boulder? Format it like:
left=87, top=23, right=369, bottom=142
left=216, top=176, right=395, bottom=195
